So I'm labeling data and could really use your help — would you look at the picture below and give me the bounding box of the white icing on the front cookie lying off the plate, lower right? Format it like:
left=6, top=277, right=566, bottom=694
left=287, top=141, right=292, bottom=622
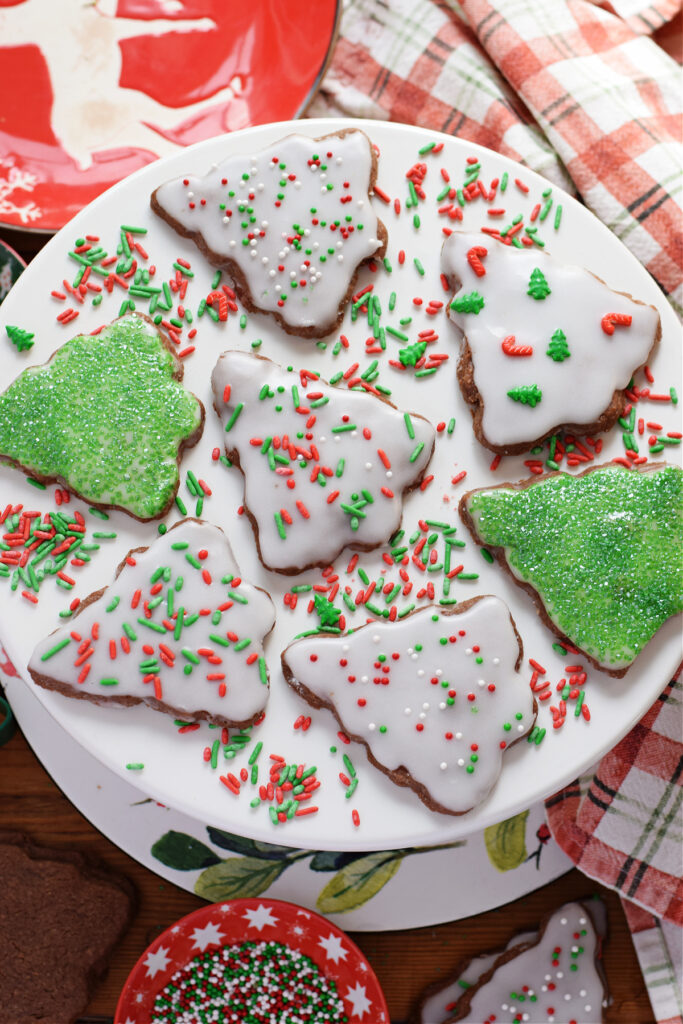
left=462, top=903, right=603, bottom=1024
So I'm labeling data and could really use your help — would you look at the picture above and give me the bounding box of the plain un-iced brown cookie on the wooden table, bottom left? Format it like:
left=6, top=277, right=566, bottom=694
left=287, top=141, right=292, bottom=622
left=0, top=830, right=135, bottom=1024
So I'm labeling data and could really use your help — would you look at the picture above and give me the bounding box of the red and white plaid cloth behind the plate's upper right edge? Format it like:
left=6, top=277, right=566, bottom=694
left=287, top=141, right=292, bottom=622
left=309, top=0, right=683, bottom=313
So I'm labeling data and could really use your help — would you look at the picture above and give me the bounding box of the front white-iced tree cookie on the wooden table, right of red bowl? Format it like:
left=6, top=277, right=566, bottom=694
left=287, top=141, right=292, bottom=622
left=446, top=903, right=607, bottom=1024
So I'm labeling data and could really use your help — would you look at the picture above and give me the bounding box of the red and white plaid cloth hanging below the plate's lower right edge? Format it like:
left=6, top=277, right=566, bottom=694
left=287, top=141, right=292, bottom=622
left=546, top=676, right=683, bottom=1024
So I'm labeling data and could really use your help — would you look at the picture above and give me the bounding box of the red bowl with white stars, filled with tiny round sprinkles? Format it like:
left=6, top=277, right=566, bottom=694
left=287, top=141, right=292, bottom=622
left=114, top=899, right=389, bottom=1024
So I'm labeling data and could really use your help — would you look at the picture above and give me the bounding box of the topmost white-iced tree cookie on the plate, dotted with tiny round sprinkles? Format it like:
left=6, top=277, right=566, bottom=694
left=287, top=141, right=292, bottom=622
left=152, top=128, right=386, bottom=338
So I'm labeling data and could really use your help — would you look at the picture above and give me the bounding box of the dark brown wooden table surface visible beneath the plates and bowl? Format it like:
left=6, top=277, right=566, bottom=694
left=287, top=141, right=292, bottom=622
left=0, top=14, right=682, bottom=1003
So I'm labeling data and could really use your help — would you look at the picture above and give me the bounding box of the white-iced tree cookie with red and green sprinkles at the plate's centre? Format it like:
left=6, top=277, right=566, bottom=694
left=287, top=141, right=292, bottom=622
left=212, top=351, right=435, bottom=573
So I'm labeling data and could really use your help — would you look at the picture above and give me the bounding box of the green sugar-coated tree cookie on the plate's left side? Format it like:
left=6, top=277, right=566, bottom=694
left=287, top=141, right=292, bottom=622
left=0, top=314, right=204, bottom=520
